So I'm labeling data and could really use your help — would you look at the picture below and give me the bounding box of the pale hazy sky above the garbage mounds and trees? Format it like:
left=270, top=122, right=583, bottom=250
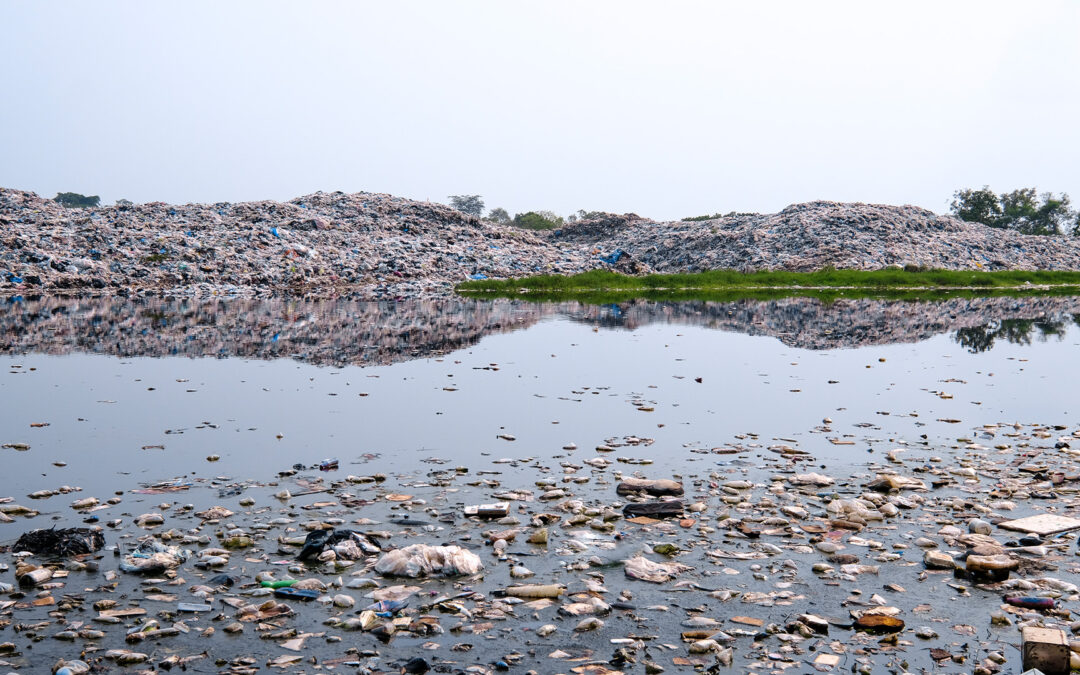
left=0, top=0, right=1080, bottom=218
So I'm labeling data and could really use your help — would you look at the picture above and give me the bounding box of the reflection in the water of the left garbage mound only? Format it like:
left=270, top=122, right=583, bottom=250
left=0, top=297, right=553, bottom=365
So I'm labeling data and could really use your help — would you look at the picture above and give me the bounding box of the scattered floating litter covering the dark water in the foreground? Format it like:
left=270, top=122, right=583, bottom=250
left=6, top=419, right=1080, bottom=675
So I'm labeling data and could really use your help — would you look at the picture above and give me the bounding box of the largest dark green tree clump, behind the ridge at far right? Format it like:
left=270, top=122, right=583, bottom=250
left=950, top=186, right=1080, bottom=234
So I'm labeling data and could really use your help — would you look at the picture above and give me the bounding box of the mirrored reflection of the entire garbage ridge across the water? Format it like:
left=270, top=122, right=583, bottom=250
left=0, top=297, right=1080, bottom=365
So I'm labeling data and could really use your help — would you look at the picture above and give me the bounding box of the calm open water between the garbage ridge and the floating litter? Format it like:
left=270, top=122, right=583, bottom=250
left=0, top=300, right=1080, bottom=494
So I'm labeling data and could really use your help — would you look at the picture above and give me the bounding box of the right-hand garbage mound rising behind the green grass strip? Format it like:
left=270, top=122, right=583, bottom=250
left=583, top=201, right=1080, bottom=272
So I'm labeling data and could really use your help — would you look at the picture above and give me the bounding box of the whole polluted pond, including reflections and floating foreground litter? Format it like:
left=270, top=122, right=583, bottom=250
left=0, top=297, right=1080, bottom=675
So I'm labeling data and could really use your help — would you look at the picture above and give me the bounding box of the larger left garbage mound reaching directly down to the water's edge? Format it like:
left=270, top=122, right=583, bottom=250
left=0, top=189, right=585, bottom=297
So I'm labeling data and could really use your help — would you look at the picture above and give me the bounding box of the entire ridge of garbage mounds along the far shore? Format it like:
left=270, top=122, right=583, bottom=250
left=6, top=188, right=1080, bottom=299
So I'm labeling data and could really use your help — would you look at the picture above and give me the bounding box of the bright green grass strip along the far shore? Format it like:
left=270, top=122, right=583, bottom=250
left=457, top=269, right=1080, bottom=301
